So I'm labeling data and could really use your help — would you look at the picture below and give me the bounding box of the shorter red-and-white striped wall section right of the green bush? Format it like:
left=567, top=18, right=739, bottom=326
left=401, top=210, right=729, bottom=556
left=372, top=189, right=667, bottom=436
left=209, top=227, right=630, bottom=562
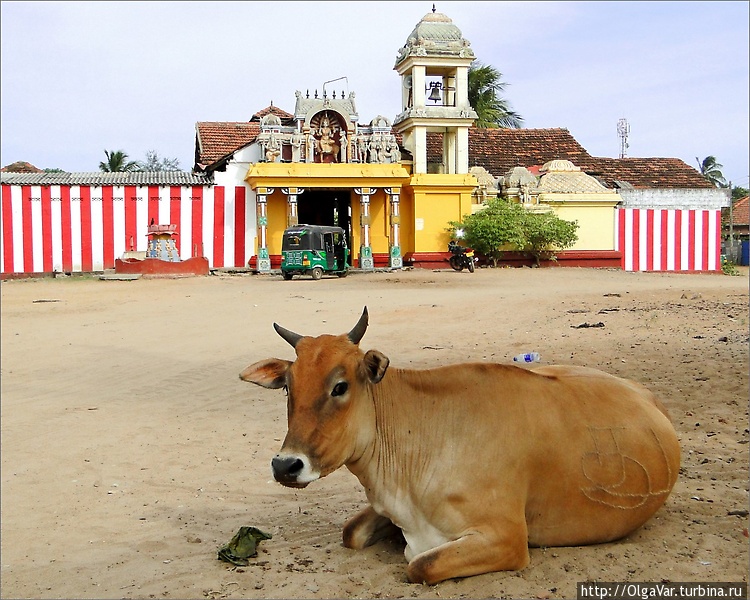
left=615, top=208, right=721, bottom=272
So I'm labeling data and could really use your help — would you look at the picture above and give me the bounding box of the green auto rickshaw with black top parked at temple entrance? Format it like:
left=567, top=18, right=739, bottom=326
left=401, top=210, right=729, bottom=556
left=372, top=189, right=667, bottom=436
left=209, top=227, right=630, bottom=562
left=281, top=225, right=349, bottom=281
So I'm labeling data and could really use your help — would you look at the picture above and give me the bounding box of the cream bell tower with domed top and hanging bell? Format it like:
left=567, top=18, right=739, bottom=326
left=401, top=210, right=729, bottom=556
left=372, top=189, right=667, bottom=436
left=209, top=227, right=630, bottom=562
left=393, top=5, right=477, bottom=175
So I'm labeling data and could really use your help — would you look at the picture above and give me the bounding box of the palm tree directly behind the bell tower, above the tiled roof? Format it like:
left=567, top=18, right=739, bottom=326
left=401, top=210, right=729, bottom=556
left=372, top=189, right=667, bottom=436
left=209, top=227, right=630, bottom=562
left=469, top=61, right=523, bottom=129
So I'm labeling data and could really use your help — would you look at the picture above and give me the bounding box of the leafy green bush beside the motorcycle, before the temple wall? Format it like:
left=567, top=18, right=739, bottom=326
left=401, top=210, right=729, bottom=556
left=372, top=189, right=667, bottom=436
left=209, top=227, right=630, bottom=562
left=448, top=198, right=578, bottom=266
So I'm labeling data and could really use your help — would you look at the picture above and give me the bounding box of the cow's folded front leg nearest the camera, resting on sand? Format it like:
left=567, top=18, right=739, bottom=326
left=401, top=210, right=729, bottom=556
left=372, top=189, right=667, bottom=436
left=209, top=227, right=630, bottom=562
left=407, top=522, right=529, bottom=584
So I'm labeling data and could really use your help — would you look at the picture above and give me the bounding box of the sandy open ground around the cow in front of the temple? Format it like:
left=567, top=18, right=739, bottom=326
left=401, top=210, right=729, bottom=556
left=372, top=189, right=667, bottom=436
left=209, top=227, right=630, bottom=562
left=1, top=269, right=750, bottom=598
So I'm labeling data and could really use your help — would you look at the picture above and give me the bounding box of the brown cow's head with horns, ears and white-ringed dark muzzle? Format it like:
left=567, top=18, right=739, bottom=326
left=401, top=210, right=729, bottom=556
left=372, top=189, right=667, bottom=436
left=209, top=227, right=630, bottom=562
left=240, top=309, right=388, bottom=487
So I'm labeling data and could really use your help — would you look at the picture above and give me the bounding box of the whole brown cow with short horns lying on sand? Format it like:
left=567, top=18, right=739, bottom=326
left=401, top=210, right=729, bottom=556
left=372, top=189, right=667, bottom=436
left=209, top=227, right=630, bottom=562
left=240, top=308, right=680, bottom=584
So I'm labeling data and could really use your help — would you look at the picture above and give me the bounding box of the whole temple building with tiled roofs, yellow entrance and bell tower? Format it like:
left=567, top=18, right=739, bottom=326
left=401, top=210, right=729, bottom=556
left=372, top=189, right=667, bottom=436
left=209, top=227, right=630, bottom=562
left=188, top=10, right=724, bottom=272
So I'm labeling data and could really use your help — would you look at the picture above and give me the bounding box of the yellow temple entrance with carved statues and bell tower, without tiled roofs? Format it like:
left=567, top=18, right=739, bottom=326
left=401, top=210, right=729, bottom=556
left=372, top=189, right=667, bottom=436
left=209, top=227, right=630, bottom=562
left=236, top=11, right=477, bottom=271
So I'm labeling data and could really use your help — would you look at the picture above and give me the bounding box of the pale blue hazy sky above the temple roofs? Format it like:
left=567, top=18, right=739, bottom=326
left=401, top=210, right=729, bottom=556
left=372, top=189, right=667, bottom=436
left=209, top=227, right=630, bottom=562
left=0, top=0, right=750, bottom=187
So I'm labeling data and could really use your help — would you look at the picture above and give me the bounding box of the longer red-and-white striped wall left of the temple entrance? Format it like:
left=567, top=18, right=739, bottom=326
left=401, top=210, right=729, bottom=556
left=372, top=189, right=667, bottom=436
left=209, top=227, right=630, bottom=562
left=0, top=185, right=255, bottom=275
